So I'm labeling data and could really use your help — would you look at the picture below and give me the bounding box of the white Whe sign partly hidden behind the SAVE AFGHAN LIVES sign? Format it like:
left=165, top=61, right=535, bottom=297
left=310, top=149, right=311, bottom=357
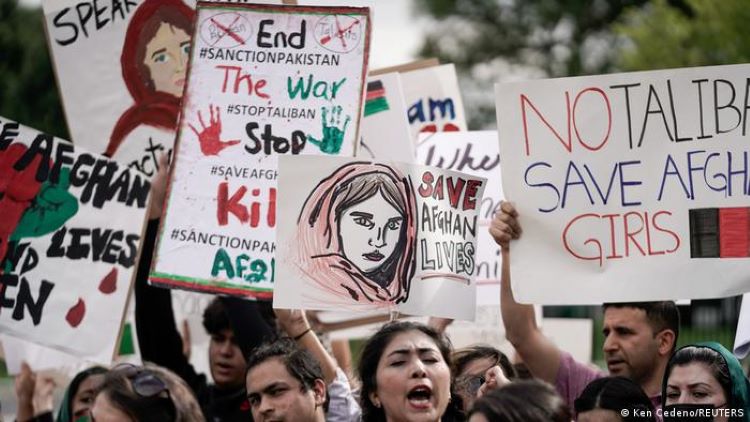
left=417, top=131, right=503, bottom=306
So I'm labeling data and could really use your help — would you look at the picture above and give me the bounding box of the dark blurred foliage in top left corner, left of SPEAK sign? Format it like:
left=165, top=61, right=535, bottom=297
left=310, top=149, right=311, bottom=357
left=0, top=0, right=70, bottom=139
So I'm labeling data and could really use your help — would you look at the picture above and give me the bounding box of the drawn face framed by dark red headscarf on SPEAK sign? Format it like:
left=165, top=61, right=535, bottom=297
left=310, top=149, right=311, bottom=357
left=144, top=23, right=190, bottom=98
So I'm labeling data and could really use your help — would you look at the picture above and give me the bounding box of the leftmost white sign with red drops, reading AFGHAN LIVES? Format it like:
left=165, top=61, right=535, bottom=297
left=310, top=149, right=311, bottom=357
left=0, top=118, right=150, bottom=363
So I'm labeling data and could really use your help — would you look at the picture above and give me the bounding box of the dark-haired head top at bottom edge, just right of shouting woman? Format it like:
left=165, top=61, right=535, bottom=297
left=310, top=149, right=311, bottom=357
left=469, top=380, right=571, bottom=422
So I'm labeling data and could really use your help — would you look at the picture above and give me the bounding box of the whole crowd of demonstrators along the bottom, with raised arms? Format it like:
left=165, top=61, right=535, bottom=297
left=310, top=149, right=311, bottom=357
left=10, top=161, right=750, bottom=422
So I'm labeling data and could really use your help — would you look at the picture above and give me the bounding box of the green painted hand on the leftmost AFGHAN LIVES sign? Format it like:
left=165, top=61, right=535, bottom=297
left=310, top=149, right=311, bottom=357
left=10, top=168, right=78, bottom=240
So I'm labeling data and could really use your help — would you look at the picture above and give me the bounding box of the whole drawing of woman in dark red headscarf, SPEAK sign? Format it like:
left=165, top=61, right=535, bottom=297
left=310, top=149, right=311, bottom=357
left=105, top=0, right=195, bottom=157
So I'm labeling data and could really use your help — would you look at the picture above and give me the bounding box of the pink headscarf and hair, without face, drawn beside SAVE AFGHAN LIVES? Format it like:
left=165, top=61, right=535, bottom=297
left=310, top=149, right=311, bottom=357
left=297, top=162, right=417, bottom=304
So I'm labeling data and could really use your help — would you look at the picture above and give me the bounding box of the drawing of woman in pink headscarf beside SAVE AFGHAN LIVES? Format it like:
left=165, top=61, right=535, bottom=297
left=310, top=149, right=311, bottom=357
left=297, top=162, right=417, bottom=304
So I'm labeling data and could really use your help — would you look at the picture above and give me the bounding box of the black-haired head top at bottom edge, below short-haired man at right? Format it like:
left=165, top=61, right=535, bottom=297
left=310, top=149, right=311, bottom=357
left=575, top=377, right=656, bottom=422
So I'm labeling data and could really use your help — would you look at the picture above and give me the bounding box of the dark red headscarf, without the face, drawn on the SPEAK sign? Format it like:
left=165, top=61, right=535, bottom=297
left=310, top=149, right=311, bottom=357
left=104, top=0, right=195, bottom=157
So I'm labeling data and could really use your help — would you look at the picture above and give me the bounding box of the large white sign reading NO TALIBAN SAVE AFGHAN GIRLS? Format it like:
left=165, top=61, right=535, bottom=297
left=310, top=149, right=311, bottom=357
left=496, top=65, right=750, bottom=304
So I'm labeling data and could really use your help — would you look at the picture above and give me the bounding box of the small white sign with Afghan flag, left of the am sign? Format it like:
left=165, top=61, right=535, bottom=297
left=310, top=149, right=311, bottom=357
left=357, top=73, right=414, bottom=163
